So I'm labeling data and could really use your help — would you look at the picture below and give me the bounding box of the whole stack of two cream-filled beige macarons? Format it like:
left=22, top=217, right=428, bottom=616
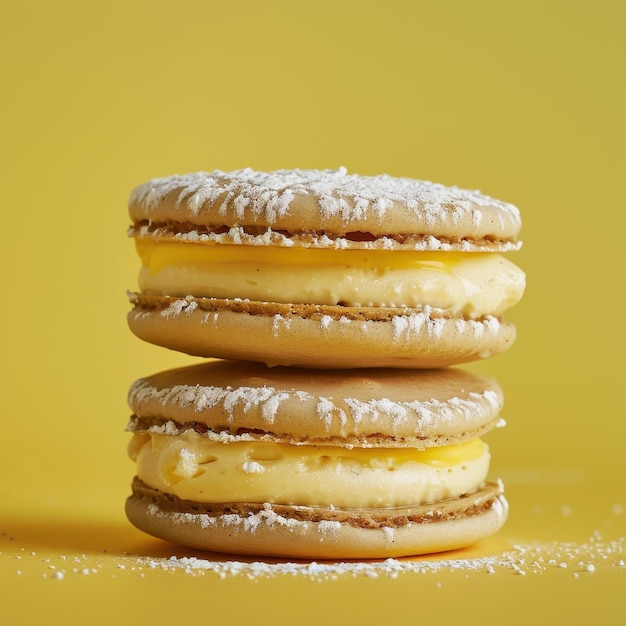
left=126, top=169, right=525, bottom=559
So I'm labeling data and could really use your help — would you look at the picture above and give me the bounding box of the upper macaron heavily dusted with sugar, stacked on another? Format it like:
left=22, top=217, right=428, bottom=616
left=128, top=168, right=525, bottom=369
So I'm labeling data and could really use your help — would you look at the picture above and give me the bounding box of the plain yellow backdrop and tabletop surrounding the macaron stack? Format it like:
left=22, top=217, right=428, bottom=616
left=0, top=0, right=626, bottom=625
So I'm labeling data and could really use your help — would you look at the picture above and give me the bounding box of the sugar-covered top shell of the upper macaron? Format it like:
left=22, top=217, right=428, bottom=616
left=129, top=168, right=521, bottom=250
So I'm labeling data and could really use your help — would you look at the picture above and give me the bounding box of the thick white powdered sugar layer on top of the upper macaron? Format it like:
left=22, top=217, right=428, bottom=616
left=129, top=167, right=520, bottom=226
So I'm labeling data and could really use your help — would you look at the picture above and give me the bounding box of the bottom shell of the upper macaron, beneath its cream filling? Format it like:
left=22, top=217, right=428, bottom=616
left=128, top=294, right=515, bottom=368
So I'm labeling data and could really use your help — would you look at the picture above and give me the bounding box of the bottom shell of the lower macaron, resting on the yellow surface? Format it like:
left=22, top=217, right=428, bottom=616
left=126, top=479, right=508, bottom=559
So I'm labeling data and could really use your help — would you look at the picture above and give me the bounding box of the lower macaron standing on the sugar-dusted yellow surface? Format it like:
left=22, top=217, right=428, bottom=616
left=126, top=360, right=508, bottom=559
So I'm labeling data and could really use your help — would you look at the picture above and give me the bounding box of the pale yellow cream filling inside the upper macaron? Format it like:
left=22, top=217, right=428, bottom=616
left=136, top=239, right=525, bottom=319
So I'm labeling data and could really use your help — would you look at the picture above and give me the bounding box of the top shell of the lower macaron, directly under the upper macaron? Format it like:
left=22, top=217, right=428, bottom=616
left=128, top=361, right=503, bottom=449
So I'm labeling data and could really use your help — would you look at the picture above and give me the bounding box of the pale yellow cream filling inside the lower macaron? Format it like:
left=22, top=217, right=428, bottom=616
left=129, top=431, right=490, bottom=508
